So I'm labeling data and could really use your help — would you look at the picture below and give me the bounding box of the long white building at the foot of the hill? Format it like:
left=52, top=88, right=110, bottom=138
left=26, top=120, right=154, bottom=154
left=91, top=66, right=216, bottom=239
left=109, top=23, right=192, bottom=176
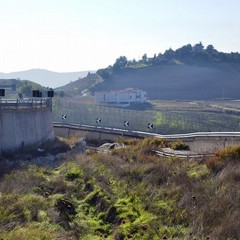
left=95, top=88, right=147, bottom=103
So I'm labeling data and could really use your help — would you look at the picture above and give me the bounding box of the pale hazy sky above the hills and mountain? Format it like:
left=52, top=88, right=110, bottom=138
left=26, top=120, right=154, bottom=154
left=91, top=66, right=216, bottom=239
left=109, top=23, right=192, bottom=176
left=0, top=0, right=240, bottom=72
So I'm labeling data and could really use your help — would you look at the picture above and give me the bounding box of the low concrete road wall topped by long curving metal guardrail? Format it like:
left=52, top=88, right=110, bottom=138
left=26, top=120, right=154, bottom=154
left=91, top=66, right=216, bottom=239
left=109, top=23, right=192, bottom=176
left=53, top=122, right=240, bottom=153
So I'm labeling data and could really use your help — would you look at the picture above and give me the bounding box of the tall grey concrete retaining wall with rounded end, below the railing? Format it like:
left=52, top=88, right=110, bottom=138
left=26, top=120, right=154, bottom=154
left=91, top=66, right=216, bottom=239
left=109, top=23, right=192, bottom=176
left=0, top=108, right=54, bottom=153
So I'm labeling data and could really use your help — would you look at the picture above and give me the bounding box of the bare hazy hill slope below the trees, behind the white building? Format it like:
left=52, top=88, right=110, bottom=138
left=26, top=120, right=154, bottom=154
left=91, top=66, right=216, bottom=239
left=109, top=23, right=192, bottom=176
left=95, top=64, right=240, bottom=100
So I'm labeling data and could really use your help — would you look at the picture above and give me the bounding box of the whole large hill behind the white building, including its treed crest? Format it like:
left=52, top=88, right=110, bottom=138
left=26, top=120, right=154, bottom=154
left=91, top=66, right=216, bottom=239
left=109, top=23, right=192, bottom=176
left=91, top=42, right=240, bottom=100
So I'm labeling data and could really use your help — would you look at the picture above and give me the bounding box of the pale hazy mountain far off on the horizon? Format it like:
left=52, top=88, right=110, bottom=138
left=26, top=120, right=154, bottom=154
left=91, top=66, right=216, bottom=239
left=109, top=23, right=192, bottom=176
left=0, top=69, right=95, bottom=88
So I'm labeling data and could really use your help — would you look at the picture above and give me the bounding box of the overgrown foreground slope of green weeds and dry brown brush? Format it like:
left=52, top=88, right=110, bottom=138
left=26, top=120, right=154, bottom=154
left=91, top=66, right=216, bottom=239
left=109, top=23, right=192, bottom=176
left=0, top=139, right=240, bottom=240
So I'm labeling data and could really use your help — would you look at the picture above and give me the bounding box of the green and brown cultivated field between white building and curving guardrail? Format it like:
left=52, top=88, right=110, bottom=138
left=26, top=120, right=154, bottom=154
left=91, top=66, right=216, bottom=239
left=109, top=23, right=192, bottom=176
left=53, top=98, right=240, bottom=134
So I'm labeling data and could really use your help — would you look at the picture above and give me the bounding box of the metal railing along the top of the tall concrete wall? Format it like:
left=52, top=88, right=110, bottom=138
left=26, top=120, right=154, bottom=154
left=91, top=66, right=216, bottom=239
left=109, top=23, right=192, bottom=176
left=0, top=98, right=52, bottom=109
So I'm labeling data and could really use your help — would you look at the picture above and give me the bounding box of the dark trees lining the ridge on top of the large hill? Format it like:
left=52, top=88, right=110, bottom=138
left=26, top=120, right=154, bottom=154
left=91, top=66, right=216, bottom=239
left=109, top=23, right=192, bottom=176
left=97, top=42, right=240, bottom=79
